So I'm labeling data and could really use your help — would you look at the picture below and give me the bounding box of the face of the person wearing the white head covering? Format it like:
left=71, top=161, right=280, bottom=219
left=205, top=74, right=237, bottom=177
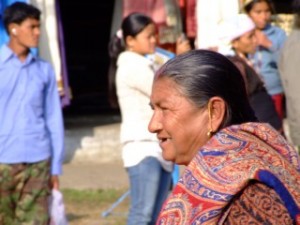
left=232, top=30, right=257, bottom=54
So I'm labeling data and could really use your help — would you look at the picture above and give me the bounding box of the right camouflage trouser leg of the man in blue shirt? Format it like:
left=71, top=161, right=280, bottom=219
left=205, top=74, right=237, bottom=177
left=15, top=160, right=50, bottom=225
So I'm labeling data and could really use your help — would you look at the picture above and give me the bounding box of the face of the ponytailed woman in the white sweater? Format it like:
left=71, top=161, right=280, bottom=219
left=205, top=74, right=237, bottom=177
left=127, top=24, right=156, bottom=55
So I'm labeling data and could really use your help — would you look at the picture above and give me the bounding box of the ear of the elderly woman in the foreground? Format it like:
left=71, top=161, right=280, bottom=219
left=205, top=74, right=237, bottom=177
left=207, top=97, right=226, bottom=133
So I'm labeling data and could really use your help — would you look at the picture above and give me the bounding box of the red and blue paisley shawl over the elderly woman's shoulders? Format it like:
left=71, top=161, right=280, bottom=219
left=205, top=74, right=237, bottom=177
left=157, top=123, right=300, bottom=225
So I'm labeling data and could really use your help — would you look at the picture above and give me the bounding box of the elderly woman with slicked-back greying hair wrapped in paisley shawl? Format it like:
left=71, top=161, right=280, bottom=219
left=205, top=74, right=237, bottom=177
left=148, top=50, right=300, bottom=225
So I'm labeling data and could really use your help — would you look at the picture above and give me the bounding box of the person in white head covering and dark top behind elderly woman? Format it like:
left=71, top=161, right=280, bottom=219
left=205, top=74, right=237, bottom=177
left=218, top=14, right=282, bottom=132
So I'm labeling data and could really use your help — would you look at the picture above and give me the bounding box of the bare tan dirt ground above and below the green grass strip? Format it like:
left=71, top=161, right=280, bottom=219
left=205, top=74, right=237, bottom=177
left=60, top=161, right=129, bottom=225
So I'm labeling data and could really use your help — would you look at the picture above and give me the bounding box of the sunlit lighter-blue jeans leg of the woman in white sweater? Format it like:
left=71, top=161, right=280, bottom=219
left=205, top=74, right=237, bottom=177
left=127, top=157, right=161, bottom=225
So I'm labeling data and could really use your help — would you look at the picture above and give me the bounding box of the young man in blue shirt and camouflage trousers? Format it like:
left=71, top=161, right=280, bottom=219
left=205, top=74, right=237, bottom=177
left=0, top=2, right=64, bottom=224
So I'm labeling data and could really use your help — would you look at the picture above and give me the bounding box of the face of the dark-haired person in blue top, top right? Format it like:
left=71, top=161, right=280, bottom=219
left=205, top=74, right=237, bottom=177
left=249, top=2, right=271, bottom=30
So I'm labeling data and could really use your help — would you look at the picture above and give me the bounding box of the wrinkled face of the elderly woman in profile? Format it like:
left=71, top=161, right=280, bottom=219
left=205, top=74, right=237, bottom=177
left=148, top=77, right=208, bottom=165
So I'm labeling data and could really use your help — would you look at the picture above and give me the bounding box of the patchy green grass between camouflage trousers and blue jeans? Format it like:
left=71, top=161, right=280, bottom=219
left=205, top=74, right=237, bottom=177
left=61, top=189, right=129, bottom=225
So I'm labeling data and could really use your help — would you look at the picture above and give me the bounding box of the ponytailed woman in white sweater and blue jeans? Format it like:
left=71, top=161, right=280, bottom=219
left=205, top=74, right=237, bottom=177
left=109, top=13, right=190, bottom=225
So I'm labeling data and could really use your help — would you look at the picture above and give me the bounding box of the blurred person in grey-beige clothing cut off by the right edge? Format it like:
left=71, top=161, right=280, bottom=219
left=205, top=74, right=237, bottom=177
left=279, top=0, right=300, bottom=152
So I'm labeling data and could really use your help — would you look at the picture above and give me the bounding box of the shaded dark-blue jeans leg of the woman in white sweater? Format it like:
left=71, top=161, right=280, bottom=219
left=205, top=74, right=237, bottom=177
left=149, top=167, right=172, bottom=225
